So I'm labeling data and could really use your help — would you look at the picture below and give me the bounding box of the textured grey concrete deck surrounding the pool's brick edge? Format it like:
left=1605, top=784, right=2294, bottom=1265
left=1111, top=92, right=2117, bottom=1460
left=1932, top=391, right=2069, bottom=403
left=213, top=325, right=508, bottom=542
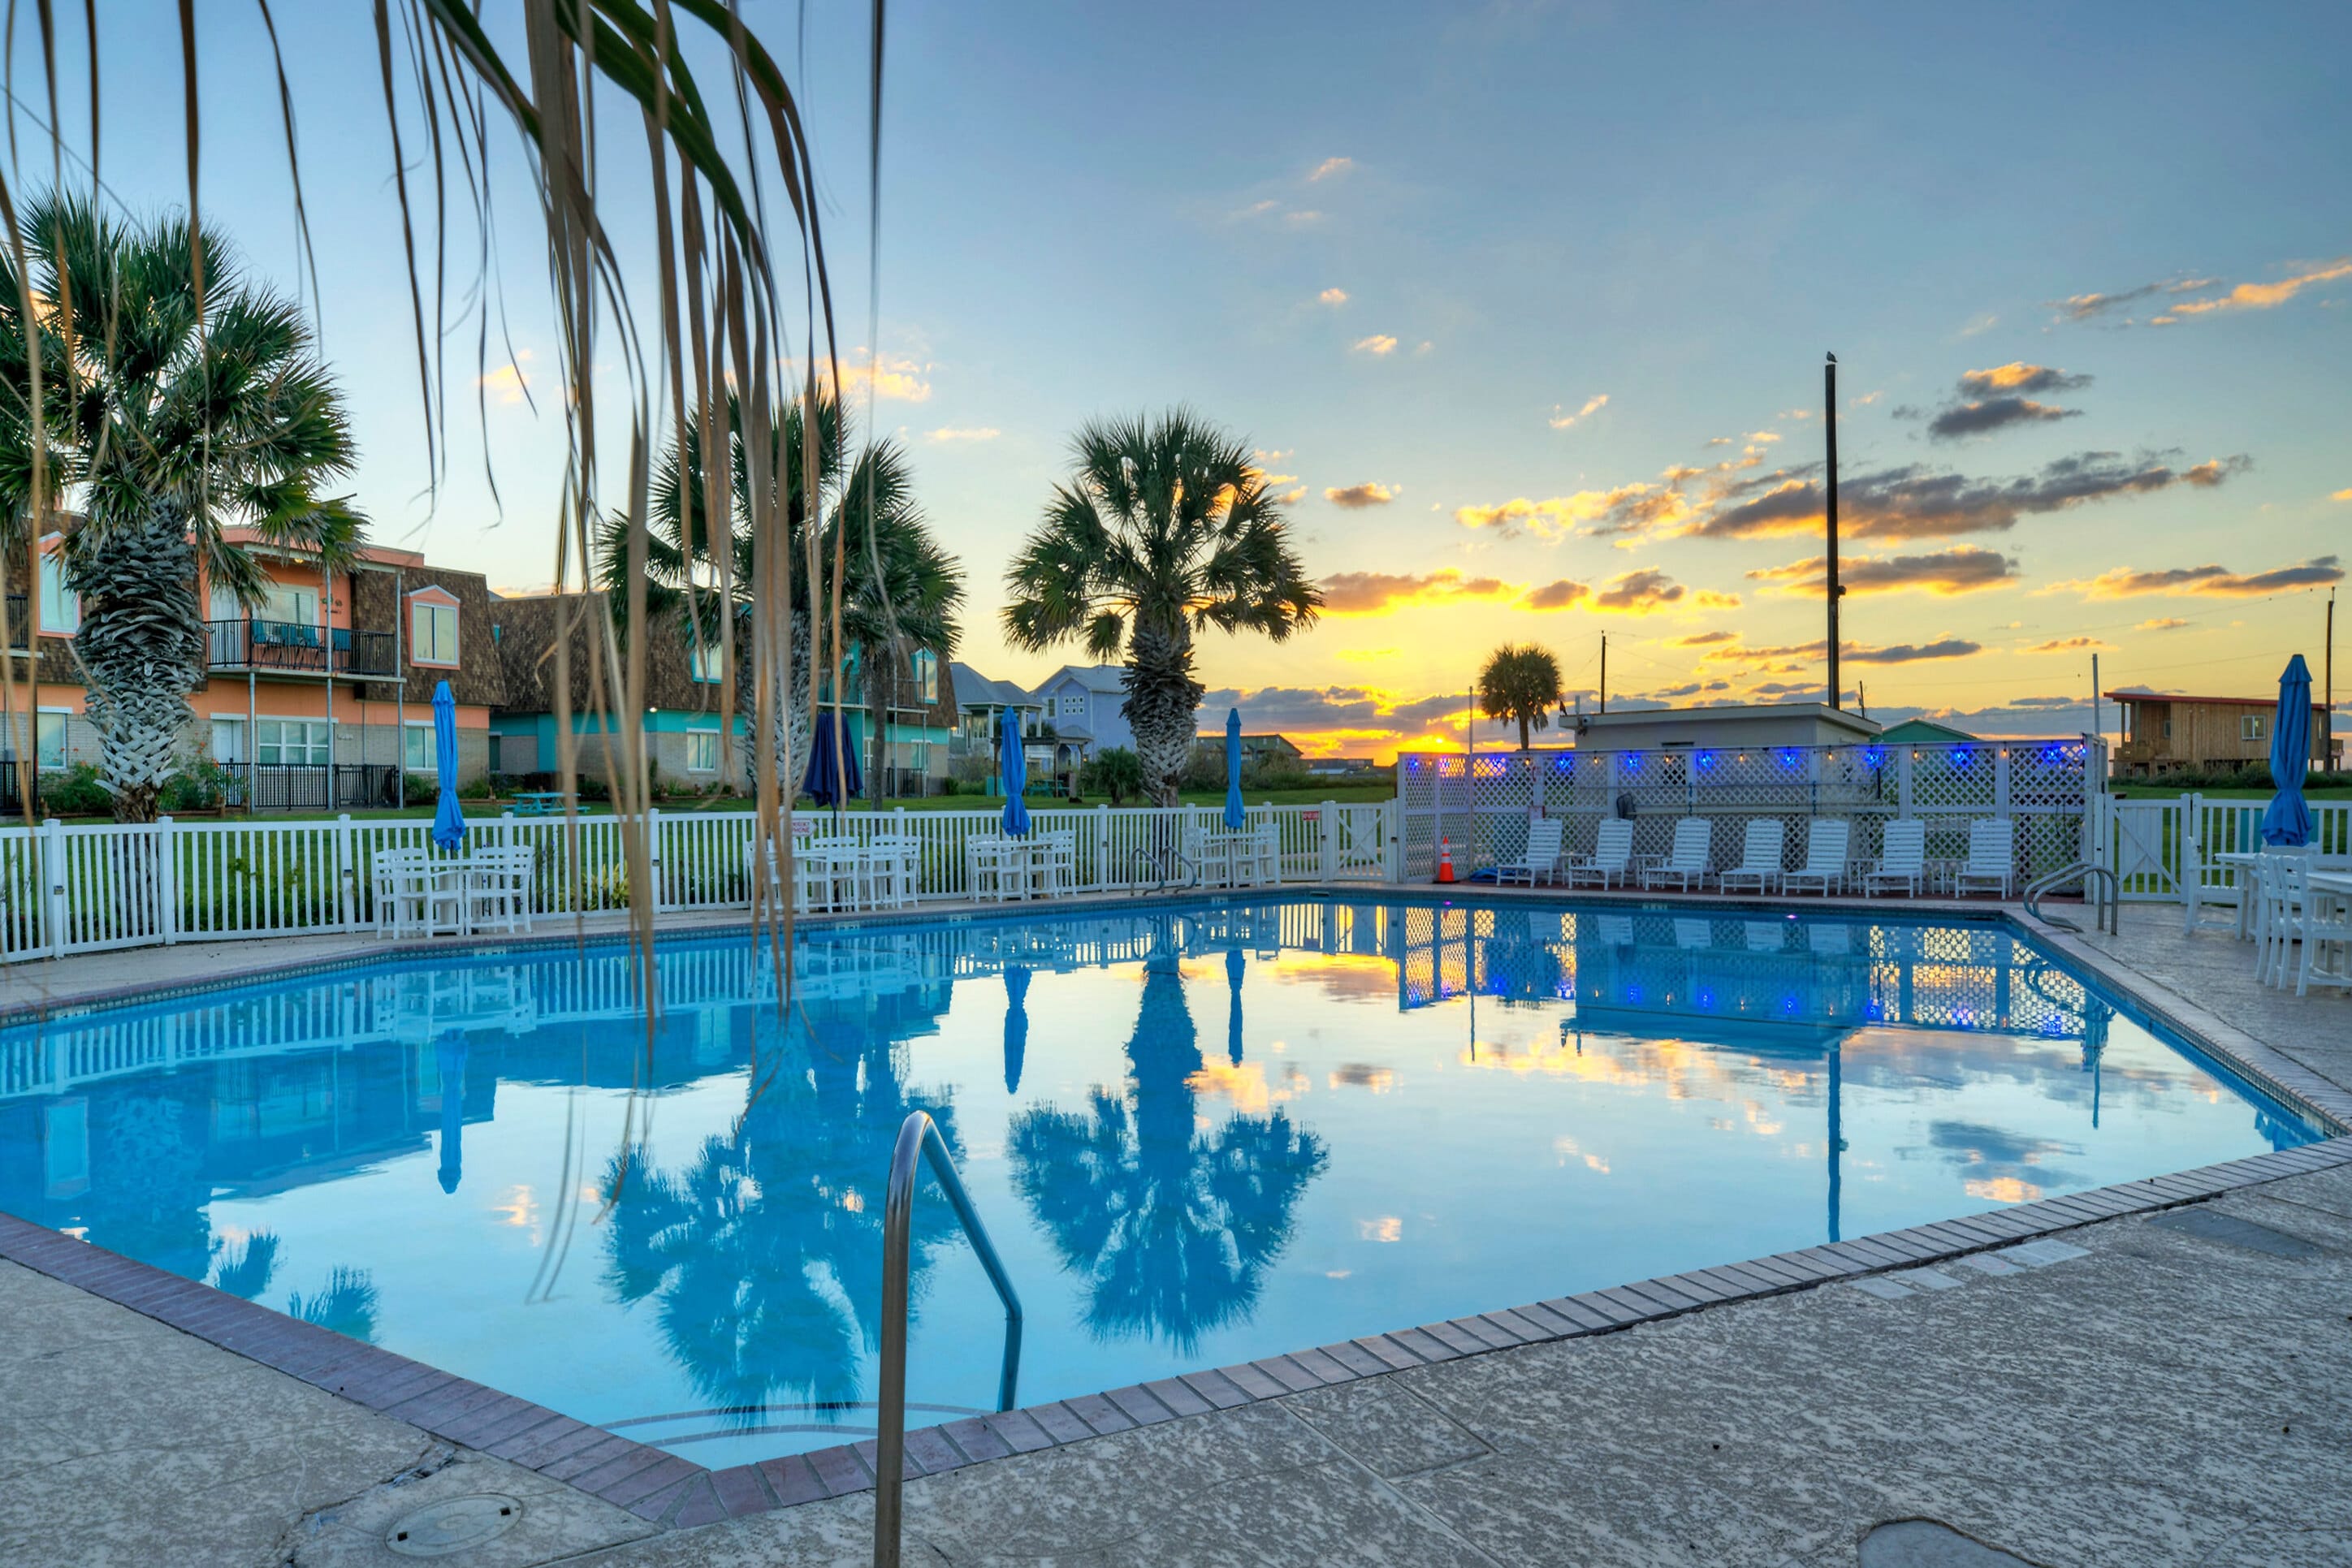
left=0, top=888, right=2352, bottom=1568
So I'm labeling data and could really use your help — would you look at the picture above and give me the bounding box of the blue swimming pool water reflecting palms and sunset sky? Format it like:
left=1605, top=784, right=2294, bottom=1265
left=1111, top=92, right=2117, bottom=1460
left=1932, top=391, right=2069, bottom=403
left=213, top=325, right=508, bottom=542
left=0, top=898, right=2319, bottom=1465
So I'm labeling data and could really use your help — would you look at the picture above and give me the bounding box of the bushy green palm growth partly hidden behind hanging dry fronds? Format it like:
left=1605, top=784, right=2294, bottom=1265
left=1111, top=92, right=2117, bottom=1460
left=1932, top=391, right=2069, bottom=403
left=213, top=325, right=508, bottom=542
left=598, top=392, right=964, bottom=795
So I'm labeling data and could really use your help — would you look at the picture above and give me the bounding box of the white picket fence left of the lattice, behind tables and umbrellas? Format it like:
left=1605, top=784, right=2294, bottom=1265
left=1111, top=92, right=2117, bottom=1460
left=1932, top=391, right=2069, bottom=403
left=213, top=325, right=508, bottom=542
left=0, top=801, right=1397, bottom=961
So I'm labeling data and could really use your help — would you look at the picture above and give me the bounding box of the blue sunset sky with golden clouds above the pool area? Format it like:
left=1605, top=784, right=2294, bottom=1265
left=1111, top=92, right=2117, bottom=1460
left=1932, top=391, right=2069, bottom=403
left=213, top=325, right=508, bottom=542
left=11, top=0, right=2352, bottom=757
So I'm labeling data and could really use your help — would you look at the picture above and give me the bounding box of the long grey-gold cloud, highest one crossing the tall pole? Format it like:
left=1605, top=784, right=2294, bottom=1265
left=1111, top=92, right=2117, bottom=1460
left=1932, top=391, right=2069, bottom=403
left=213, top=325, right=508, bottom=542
left=1682, top=451, right=2250, bottom=538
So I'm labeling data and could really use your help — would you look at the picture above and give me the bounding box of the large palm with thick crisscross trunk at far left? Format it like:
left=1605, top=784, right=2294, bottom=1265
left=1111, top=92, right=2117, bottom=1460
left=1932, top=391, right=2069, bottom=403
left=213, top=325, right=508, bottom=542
left=0, top=195, right=360, bottom=823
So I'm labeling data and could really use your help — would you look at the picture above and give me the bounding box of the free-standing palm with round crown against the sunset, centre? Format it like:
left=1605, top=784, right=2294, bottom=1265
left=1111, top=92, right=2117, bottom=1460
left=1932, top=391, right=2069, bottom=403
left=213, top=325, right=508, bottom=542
left=1005, top=409, right=1322, bottom=806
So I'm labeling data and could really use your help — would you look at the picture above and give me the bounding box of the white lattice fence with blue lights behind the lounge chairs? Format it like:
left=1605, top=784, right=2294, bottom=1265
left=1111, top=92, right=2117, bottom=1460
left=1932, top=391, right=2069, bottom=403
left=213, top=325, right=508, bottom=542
left=1397, top=738, right=2105, bottom=882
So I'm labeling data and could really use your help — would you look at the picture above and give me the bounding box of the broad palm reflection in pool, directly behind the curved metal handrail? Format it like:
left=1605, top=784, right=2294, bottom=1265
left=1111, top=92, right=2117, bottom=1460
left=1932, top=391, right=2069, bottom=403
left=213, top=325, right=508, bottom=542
left=604, top=1009, right=962, bottom=1427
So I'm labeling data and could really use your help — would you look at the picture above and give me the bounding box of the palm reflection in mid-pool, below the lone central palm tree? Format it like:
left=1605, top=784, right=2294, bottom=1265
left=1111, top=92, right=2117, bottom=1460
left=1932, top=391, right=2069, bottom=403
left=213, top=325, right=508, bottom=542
left=1009, top=929, right=1329, bottom=1352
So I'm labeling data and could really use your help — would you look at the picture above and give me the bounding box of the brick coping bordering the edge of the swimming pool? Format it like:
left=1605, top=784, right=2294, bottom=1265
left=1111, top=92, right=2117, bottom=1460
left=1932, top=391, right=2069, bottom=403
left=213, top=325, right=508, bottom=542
left=0, top=886, right=2352, bottom=1528
